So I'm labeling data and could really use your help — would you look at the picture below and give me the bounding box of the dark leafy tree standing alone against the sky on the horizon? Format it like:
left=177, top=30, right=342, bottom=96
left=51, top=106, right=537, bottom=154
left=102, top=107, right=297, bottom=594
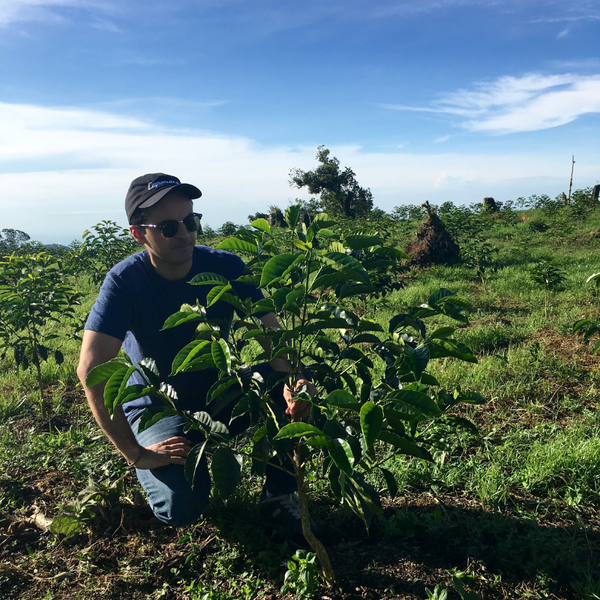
left=290, top=146, right=373, bottom=218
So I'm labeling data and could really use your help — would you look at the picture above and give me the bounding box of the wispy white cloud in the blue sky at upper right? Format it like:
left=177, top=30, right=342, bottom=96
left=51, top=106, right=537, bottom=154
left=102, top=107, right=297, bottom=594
left=385, top=73, right=600, bottom=134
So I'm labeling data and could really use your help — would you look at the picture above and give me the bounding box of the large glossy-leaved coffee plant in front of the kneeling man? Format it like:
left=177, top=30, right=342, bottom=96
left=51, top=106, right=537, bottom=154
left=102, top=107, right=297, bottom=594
left=87, top=205, right=484, bottom=585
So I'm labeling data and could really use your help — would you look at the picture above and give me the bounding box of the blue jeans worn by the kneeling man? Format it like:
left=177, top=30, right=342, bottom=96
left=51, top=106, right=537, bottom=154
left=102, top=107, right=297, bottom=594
left=132, top=360, right=297, bottom=527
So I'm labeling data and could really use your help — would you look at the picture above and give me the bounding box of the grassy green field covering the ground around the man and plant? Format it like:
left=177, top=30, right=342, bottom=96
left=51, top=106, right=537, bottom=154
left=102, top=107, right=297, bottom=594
left=0, top=196, right=600, bottom=600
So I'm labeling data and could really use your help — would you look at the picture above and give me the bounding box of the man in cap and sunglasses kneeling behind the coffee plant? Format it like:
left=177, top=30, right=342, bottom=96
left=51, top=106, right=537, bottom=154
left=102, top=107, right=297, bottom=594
left=77, top=173, right=310, bottom=538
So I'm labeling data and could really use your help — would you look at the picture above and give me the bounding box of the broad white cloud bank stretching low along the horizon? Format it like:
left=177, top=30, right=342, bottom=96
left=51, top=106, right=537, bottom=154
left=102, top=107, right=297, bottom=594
left=0, top=104, right=600, bottom=243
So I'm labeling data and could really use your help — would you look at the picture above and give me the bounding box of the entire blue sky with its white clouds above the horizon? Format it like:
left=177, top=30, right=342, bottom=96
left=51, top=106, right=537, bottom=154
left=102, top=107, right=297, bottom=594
left=0, top=0, right=600, bottom=243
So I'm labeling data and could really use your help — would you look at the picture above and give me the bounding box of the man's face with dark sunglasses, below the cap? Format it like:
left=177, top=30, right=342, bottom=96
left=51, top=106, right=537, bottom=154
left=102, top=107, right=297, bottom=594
left=130, top=191, right=198, bottom=278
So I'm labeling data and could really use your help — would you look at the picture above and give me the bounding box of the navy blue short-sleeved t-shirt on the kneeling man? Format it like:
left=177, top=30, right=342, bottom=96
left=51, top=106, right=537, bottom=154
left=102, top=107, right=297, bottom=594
left=85, top=246, right=263, bottom=422
